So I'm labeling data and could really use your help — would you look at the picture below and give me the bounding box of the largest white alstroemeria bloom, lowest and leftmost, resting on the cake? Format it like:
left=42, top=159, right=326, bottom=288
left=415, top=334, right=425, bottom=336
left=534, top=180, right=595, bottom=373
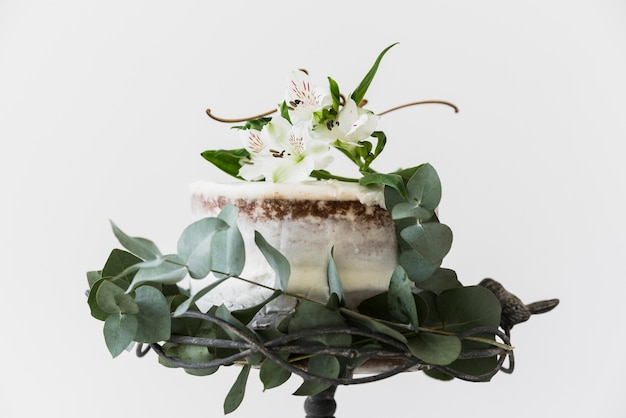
left=239, top=116, right=332, bottom=183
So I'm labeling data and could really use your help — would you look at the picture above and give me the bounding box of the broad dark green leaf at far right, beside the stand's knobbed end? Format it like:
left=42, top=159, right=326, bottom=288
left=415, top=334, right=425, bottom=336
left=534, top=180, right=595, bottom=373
left=436, top=286, right=501, bottom=333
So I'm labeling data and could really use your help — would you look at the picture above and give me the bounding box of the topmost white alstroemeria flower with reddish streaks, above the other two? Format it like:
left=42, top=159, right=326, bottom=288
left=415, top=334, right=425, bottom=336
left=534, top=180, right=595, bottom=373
left=285, top=70, right=333, bottom=125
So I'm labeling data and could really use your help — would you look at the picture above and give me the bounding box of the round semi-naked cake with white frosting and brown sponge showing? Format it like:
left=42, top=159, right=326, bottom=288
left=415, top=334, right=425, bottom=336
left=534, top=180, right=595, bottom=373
left=191, top=181, right=398, bottom=320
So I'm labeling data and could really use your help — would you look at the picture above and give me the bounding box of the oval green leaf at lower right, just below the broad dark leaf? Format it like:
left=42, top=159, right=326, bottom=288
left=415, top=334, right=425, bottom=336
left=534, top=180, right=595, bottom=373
left=407, top=332, right=461, bottom=366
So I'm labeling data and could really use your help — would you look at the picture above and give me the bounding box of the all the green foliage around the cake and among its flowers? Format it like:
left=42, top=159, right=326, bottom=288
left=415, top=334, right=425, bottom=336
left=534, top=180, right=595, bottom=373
left=87, top=45, right=511, bottom=413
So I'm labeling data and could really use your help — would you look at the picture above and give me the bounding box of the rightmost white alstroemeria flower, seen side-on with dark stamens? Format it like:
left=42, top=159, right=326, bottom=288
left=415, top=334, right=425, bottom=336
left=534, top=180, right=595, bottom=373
left=315, top=99, right=379, bottom=146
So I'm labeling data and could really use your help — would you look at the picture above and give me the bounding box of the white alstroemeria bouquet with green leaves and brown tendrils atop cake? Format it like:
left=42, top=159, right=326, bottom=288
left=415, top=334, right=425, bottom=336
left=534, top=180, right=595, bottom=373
left=202, top=40, right=458, bottom=192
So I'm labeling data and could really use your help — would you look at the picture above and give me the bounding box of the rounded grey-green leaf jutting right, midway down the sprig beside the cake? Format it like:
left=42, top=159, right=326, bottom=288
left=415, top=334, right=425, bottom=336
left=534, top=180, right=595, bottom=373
left=400, top=222, right=452, bottom=264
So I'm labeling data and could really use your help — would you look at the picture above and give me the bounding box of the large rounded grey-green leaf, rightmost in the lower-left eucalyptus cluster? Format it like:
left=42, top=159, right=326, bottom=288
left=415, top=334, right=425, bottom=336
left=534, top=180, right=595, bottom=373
left=135, top=286, right=172, bottom=343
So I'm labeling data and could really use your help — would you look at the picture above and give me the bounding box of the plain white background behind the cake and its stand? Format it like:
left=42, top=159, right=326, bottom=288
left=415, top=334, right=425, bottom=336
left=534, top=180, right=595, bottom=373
left=0, top=0, right=626, bottom=418
